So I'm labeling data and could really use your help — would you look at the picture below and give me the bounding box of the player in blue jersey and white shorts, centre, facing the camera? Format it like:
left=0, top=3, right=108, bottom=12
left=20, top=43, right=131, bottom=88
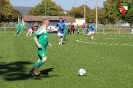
left=56, top=18, right=65, bottom=45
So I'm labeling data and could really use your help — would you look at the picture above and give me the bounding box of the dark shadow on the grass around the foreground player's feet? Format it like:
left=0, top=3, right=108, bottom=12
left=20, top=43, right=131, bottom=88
left=0, top=61, right=54, bottom=81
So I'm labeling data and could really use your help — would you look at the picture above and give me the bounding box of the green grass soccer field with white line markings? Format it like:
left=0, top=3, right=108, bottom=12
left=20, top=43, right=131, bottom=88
left=0, top=34, right=133, bottom=88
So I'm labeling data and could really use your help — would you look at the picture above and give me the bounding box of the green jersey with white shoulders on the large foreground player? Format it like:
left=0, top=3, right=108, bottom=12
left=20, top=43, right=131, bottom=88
left=34, top=27, right=48, bottom=48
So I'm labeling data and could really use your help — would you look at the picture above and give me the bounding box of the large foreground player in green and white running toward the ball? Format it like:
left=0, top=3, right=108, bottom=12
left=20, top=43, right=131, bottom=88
left=29, top=19, right=51, bottom=76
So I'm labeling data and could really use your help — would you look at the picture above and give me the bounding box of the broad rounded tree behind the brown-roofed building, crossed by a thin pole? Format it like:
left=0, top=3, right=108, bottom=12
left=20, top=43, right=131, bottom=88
left=29, top=0, right=63, bottom=16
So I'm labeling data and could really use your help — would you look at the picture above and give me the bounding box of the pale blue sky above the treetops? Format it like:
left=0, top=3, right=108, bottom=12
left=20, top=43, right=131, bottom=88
left=9, top=0, right=106, bottom=10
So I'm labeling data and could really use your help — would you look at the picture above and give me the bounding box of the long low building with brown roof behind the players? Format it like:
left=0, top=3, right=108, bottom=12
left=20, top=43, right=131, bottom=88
left=23, top=15, right=75, bottom=29
